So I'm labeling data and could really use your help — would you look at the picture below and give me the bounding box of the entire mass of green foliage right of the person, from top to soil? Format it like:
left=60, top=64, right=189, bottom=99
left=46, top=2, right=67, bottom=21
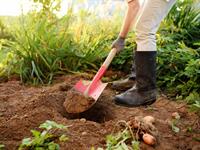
left=157, top=0, right=200, bottom=110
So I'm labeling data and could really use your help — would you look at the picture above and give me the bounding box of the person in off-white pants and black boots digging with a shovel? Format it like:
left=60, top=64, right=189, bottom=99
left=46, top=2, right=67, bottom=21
left=112, top=0, right=176, bottom=107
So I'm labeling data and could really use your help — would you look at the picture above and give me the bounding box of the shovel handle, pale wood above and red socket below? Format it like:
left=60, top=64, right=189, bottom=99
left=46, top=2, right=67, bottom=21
left=84, top=48, right=117, bottom=96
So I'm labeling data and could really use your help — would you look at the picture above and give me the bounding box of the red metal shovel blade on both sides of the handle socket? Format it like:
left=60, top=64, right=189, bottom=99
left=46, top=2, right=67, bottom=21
left=74, top=80, right=108, bottom=101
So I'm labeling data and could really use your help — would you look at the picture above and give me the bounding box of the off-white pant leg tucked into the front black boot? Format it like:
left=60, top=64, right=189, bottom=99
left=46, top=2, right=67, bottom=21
left=135, top=0, right=176, bottom=51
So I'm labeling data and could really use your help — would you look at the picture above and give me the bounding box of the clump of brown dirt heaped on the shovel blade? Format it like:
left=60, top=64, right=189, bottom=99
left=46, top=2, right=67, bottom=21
left=63, top=89, right=95, bottom=114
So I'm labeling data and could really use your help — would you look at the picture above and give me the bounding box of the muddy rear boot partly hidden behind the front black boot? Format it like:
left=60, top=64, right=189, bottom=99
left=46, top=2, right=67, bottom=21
left=112, top=54, right=136, bottom=91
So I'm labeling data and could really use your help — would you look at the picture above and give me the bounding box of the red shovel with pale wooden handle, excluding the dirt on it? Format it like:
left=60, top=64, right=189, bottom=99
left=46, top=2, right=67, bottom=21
left=74, top=48, right=117, bottom=106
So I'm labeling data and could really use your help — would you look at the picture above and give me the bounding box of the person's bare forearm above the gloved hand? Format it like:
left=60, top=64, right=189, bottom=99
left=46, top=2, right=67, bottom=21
left=119, top=0, right=140, bottom=38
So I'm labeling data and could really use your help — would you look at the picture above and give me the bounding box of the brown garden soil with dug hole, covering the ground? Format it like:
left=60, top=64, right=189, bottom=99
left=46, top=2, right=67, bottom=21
left=0, top=75, right=200, bottom=150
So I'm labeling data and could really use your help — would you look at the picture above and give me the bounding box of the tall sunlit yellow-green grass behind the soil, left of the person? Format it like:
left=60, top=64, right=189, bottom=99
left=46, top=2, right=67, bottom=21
left=0, top=0, right=117, bottom=84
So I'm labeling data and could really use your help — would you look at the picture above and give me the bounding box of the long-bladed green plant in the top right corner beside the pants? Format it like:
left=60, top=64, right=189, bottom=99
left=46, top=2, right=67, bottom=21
left=165, top=0, right=200, bottom=48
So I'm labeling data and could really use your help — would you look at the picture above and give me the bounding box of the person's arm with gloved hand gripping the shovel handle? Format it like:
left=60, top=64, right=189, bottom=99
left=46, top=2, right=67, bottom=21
left=112, top=0, right=140, bottom=52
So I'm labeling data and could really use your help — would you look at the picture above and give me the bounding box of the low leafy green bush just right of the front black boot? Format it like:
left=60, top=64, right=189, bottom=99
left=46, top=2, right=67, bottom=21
left=157, top=44, right=200, bottom=97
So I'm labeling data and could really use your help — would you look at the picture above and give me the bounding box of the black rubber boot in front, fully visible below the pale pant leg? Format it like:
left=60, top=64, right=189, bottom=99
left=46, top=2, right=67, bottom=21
left=114, top=51, right=156, bottom=107
